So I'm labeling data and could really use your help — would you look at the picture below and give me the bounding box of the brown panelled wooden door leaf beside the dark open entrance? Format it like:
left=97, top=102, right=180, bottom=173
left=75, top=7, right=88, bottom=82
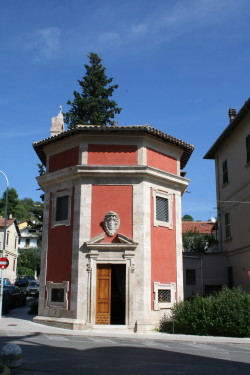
left=96, top=264, right=111, bottom=324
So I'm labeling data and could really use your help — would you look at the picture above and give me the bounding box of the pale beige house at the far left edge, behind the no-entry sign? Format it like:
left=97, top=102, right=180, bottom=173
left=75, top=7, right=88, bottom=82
left=0, top=216, right=20, bottom=283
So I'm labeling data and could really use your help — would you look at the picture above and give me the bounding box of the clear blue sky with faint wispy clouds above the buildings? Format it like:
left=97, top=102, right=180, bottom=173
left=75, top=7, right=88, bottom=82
left=0, top=0, right=250, bottom=220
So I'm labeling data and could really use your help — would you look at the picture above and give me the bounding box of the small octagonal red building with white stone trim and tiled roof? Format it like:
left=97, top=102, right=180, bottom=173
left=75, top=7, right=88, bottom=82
left=33, top=114, right=193, bottom=331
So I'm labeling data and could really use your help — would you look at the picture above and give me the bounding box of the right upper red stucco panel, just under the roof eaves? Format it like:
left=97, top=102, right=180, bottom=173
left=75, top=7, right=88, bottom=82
left=147, top=148, right=177, bottom=174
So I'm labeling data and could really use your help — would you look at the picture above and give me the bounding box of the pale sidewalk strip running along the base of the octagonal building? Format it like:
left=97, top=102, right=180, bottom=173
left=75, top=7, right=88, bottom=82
left=0, top=306, right=250, bottom=345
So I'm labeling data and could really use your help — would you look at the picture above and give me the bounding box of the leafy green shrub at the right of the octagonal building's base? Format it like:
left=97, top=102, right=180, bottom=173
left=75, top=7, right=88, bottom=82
left=159, top=287, right=250, bottom=337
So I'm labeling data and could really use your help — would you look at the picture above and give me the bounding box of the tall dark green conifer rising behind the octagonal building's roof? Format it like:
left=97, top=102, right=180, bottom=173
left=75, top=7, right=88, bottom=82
left=64, top=52, right=122, bottom=129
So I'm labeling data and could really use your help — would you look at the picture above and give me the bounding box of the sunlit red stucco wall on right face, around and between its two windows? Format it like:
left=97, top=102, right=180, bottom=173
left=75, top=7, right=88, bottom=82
left=151, top=189, right=177, bottom=309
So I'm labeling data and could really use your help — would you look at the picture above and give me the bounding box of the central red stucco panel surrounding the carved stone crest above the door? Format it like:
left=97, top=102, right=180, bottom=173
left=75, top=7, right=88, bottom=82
left=91, top=185, right=133, bottom=243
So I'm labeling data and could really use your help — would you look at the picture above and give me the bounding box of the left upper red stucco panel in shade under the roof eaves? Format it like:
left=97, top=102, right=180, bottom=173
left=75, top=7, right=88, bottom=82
left=49, top=147, right=79, bottom=172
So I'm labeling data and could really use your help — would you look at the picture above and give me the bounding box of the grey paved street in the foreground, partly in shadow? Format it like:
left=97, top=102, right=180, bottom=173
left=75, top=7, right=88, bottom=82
left=0, top=308, right=250, bottom=375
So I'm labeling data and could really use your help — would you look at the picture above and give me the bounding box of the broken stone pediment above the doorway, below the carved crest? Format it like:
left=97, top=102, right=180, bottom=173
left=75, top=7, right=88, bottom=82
left=84, top=233, right=138, bottom=250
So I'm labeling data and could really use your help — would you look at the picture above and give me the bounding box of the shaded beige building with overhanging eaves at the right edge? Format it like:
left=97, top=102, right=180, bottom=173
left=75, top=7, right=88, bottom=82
left=204, top=99, right=250, bottom=292
